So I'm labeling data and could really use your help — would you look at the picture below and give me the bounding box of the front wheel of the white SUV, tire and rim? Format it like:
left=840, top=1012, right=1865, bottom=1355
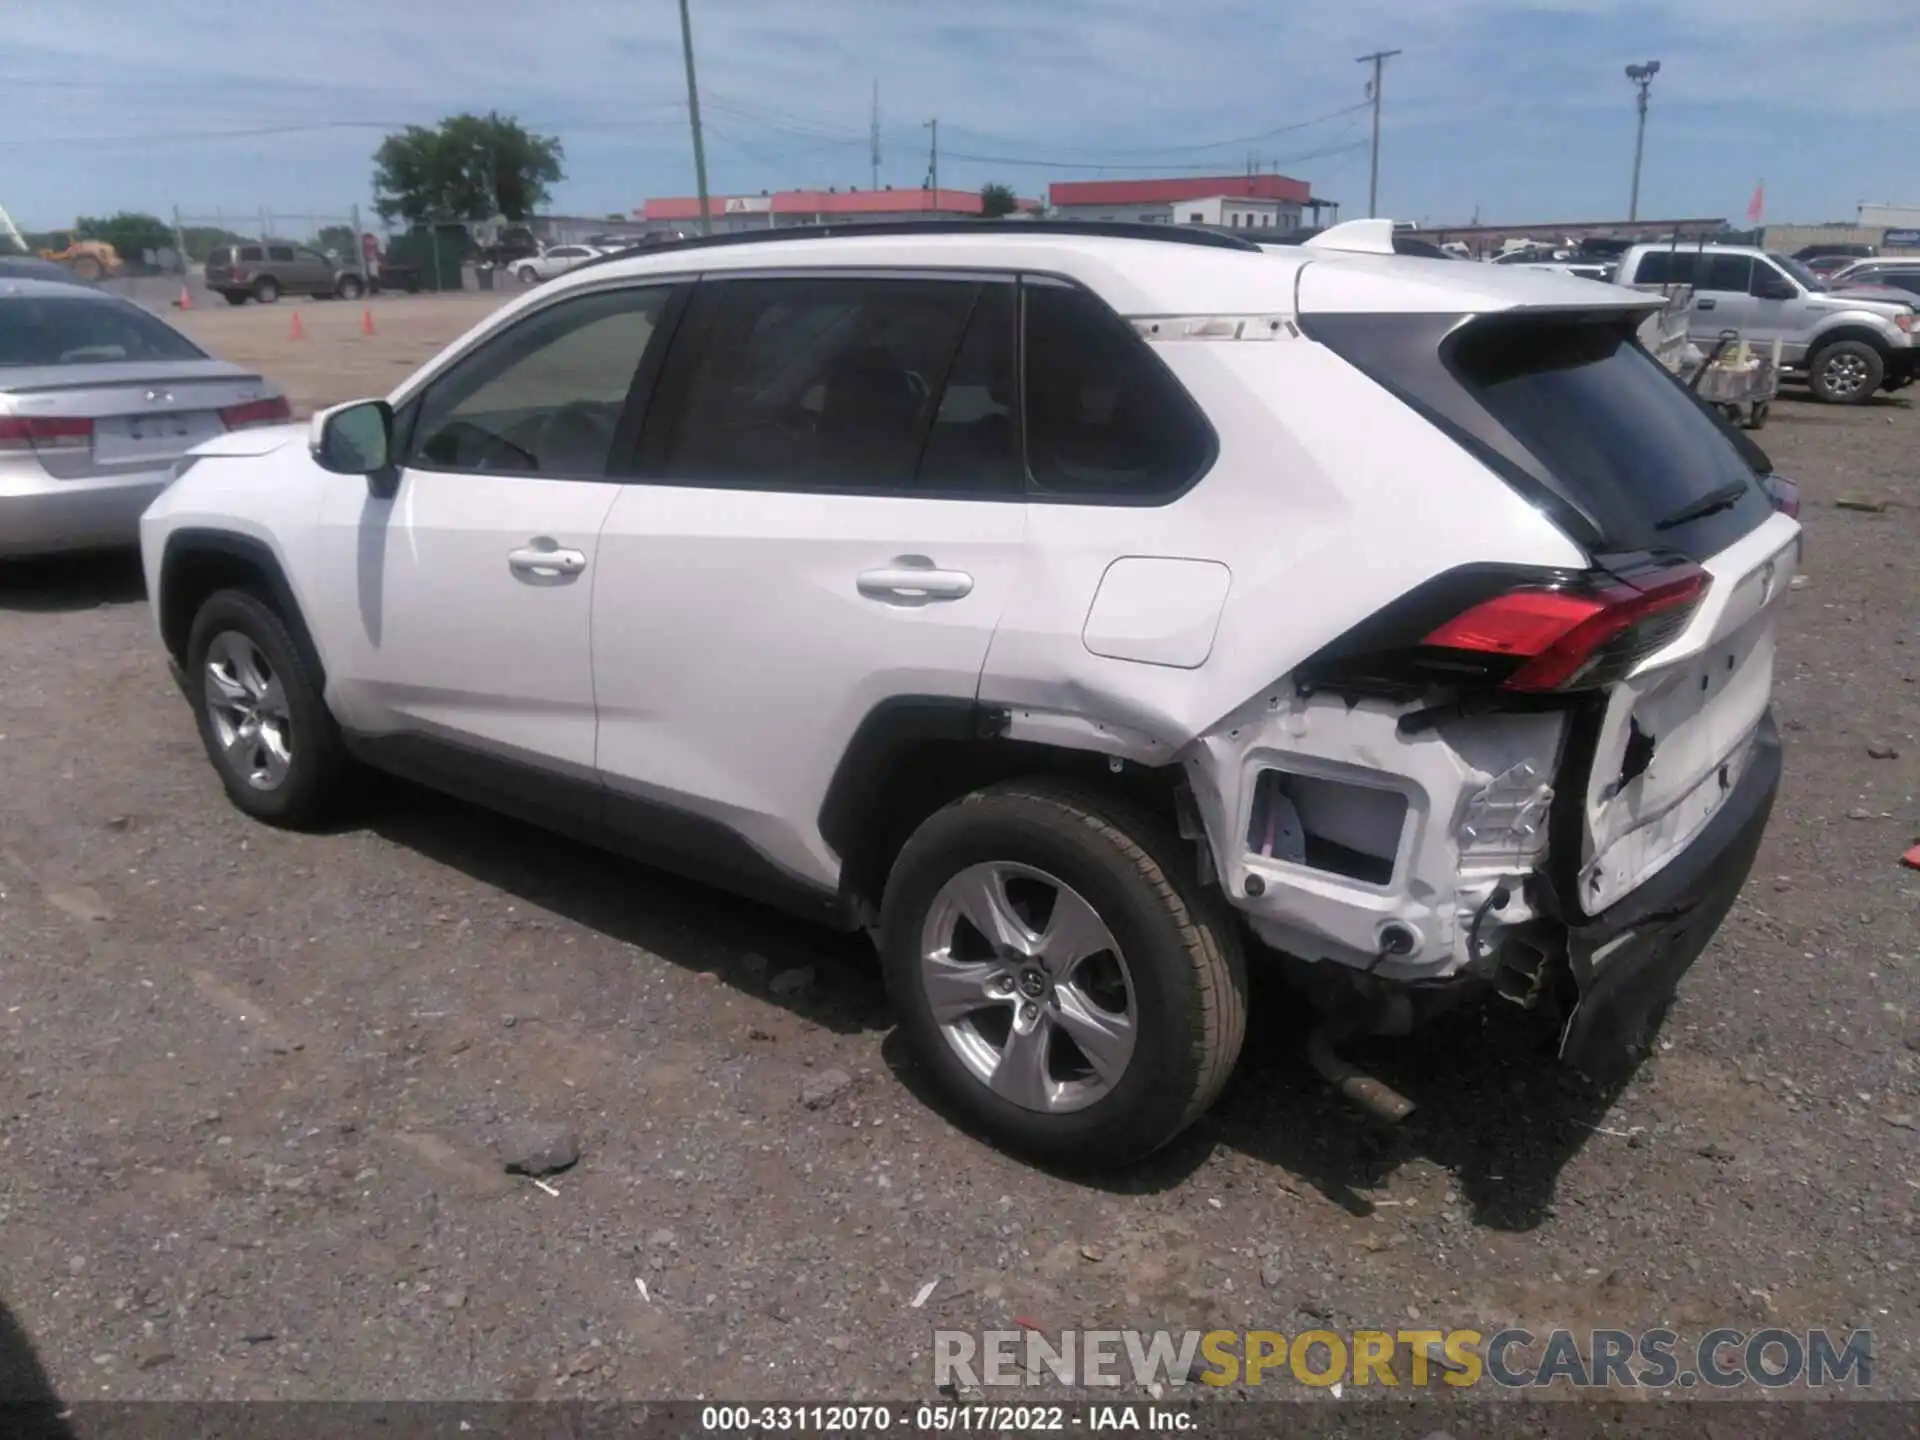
left=186, top=589, right=353, bottom=829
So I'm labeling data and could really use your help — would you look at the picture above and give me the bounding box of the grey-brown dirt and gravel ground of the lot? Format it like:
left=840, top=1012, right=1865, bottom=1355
left=0, top=311, right=1920, bottom=1400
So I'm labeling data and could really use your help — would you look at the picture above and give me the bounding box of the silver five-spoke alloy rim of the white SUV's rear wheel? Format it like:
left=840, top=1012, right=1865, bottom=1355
left=920, top=862, right=1137, bottom=1114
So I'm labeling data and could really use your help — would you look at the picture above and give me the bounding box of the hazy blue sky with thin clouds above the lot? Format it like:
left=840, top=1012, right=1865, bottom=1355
left=0, top=0, right=1920, bottom=228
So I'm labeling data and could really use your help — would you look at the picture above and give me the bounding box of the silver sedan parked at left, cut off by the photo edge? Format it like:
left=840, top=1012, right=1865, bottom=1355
left=0, top=276, right=292, bottom=557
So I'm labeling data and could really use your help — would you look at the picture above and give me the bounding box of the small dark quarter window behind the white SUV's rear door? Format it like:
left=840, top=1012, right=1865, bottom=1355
left=1025, top=284, right=1215, bottom=503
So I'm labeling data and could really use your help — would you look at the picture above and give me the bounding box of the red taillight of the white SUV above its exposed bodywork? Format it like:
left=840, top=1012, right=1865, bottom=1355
left=1421, top=564, right=1709, bottom=691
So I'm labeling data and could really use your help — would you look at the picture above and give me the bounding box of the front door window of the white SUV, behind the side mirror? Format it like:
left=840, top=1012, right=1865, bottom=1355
left=407, top=286, right=670, bottom=480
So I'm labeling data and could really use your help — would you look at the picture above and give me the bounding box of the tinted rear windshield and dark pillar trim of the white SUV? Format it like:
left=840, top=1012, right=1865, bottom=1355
left=1309, top=311, right=1772, bottom=559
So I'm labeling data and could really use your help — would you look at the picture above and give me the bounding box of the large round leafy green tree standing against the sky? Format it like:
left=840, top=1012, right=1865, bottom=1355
left=372, top=109, right=566, bottom=225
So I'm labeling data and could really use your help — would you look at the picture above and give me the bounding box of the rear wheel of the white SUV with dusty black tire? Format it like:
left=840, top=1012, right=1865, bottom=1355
left=881, top=780, right=1246, bottom=1167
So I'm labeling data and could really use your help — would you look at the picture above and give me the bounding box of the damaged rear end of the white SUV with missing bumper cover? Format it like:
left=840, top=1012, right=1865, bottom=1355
left=1228, top=288, right=1799, bottom=1114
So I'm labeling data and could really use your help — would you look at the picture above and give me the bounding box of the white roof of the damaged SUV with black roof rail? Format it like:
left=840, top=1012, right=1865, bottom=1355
left=526, top=221, right=1655, bottom=317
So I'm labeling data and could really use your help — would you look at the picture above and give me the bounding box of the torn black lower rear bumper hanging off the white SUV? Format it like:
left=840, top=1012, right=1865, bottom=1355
left=1561, top=712, right=1780, bottom=1079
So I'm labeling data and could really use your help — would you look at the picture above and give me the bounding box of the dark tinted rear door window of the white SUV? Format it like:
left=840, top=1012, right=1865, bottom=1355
left=664, top=276, right=1006, bottom=492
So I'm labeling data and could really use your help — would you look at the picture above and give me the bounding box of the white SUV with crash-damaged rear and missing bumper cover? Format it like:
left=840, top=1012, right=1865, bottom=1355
left=142, top=221, right=1799, bottom=1162
